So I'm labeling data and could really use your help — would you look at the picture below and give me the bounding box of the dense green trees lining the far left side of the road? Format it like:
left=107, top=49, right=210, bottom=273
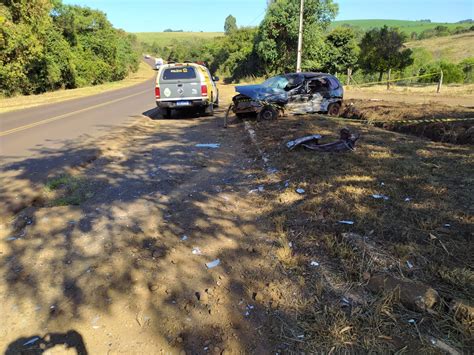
left=0, top=0, right=139, bottom=96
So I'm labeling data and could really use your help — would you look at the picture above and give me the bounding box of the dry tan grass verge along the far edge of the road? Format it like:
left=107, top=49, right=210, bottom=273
left=0, top=62, right=155, bottom=113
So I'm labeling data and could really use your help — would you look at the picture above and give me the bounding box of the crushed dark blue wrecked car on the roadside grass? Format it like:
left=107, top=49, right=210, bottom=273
left=232, top=73, right=344, bottom=120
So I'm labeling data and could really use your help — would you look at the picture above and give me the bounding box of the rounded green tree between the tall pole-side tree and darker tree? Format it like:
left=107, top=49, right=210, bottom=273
left=325, top=27, right=359, bottom=73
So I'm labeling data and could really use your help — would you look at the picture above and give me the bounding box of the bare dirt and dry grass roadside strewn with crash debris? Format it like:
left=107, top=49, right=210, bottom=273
left=0, top=86, right=474, bottom=354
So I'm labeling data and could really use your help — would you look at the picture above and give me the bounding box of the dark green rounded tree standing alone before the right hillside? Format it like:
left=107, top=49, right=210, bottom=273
left=359, top=26, right=413, bottom=81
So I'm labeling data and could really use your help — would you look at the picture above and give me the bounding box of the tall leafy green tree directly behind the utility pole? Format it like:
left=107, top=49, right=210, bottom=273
left=256, top=0, right=338, bottom=73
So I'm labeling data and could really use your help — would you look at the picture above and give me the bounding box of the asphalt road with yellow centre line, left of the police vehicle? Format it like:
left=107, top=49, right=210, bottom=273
left=0, top=76, right=155, bottom=165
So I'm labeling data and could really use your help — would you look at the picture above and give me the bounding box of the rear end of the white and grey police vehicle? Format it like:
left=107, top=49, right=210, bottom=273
left=159, top=66, right=207, bottom=106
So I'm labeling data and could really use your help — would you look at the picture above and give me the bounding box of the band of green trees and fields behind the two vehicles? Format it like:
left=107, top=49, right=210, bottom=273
left=138, top=1, right=474, bottom=86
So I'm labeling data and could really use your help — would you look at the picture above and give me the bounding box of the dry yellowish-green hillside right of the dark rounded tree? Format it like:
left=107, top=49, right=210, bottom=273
left=406, top=32, right=474, bottom=63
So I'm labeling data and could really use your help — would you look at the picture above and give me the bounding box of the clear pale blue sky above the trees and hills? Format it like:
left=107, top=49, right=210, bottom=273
left=63, top=0, right=474, bottom=32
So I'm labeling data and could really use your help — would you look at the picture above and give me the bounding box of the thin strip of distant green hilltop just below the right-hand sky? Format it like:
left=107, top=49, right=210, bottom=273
left=331, top=20, right=473, bottom=35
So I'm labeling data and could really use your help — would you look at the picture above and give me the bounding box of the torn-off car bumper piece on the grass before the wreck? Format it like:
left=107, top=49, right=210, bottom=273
left=286, top=128, right=360, bottom=152
